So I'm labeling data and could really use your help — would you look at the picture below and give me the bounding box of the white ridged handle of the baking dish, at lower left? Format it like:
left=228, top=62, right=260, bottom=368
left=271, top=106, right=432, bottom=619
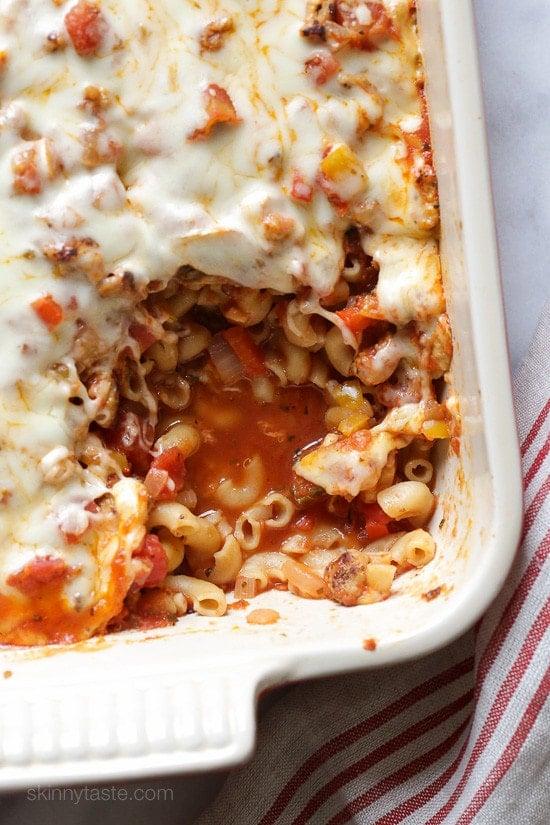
left=0, top=658, right=291, bottom=789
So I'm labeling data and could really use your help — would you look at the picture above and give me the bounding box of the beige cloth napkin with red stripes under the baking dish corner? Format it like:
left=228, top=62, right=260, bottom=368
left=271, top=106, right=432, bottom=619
left=198, top=307, right=550, bottom=825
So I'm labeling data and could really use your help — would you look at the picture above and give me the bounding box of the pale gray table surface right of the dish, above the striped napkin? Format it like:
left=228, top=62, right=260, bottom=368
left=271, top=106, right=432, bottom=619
left=478, top=0, right=550, bottom=367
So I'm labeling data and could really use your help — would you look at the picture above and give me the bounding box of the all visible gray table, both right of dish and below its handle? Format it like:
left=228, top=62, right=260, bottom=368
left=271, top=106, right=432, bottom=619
left=0, top=0, right=550, bottom=825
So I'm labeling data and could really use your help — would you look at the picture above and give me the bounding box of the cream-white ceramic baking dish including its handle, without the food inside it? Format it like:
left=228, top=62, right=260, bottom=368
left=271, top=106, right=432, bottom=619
left=0, top=0, right=521, bottom=789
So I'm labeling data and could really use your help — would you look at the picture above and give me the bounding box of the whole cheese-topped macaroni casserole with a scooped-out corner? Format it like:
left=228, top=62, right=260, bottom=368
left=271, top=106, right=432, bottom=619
left=0, top=0, right=456, bottom=645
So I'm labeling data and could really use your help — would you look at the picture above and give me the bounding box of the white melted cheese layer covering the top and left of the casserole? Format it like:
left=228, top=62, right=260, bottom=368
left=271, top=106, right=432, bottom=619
left=0, top=0, right=436, bottom=636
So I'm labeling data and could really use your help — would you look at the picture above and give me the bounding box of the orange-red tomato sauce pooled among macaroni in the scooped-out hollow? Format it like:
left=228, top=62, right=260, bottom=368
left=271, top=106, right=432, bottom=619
left=186, top=381, right=399, bottom=551
